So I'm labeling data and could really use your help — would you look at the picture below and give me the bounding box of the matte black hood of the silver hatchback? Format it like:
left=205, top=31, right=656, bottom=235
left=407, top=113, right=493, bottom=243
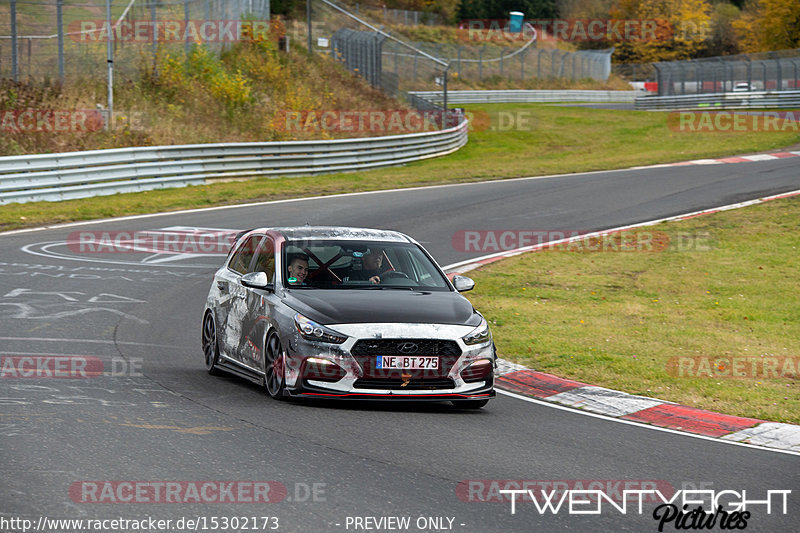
left=284, top=289, right=480, bottom=326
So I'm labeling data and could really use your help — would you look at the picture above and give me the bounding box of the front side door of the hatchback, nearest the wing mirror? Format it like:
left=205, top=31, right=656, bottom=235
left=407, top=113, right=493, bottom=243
left=234, top=235, right=278, bottom=370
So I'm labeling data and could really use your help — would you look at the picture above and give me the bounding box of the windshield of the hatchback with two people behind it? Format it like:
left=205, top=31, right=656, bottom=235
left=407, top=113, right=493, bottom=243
left=283, top=240, right=451, bottom=291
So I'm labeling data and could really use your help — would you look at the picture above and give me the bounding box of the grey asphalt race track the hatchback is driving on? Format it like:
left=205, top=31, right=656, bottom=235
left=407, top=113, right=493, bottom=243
left=0, top=159, right=800, bottom=532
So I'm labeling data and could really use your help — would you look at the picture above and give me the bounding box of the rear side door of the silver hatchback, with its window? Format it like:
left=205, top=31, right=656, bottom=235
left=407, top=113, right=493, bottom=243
left=215, top=235, right=264, bottom=363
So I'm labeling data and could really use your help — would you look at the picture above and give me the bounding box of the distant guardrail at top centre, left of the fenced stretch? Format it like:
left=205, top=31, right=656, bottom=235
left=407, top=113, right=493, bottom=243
left=410, top=89, right=636, bottom=106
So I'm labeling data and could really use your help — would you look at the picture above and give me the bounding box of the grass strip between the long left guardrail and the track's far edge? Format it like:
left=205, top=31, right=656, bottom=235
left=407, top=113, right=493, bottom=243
left=0, top=104, right=800, bottom=230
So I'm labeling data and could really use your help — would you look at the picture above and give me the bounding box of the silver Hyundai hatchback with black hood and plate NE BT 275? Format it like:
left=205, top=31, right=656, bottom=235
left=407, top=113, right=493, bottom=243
left=202, top=226, right=496, bottom=408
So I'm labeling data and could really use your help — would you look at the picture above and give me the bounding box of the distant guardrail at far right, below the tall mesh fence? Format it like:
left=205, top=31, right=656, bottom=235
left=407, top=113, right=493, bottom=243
left=636, top=91, right=800, bottom=110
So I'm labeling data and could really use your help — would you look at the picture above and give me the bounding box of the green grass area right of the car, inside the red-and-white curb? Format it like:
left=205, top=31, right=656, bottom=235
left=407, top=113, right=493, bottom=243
left=468, top=198, right=800, bottom=424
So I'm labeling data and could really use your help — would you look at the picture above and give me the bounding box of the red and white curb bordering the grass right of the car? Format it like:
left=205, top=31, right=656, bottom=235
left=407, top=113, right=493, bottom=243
left=444, top=189, right=800, bottom=452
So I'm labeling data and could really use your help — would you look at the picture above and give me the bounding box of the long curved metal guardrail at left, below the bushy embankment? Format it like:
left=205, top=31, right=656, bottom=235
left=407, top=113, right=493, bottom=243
left=0, top=119, right=467, bottom=205
